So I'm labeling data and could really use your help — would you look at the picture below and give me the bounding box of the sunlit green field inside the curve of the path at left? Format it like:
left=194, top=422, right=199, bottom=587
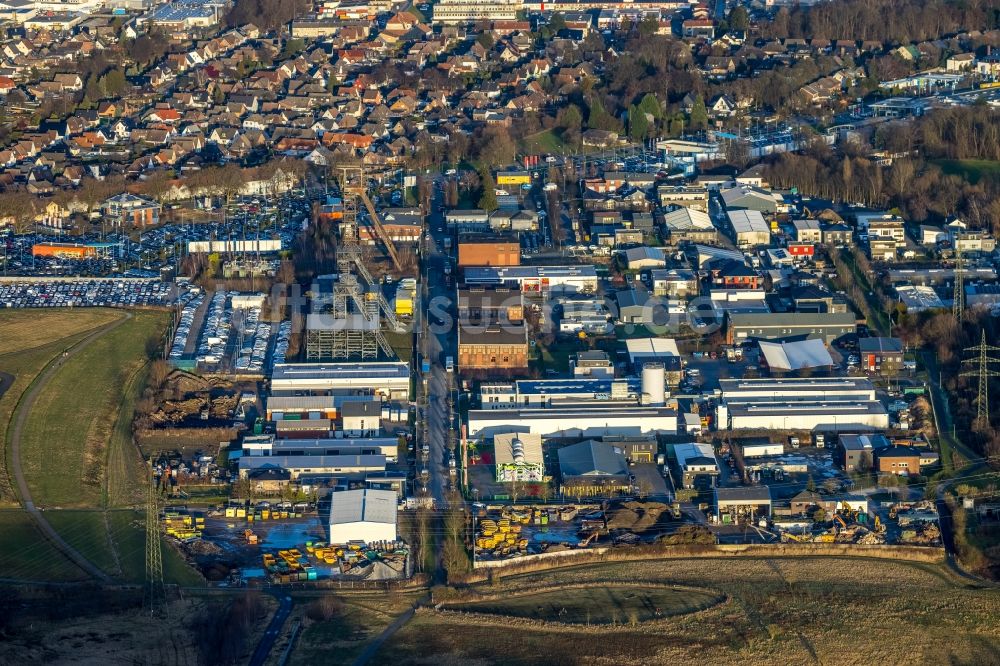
left=21, top=312, right=166, bottom=508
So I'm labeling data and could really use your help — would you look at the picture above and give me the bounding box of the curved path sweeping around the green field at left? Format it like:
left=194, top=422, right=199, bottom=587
left=10, top=312, right=132, bottom=583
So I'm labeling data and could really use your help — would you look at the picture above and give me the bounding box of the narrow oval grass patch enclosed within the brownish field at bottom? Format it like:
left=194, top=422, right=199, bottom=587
left=445, top=585, right=724, bottom=625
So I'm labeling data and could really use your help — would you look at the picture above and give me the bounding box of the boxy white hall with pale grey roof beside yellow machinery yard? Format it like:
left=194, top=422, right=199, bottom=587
left=329, top=488, right=398, bottom=545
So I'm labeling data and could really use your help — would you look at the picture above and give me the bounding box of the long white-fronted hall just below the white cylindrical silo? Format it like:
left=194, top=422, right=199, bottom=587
left=469, top=404, right=677, bottom=439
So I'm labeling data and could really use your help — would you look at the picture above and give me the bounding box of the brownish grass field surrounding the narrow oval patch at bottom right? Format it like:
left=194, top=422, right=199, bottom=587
left=375, top=557, right=1000, bottom=666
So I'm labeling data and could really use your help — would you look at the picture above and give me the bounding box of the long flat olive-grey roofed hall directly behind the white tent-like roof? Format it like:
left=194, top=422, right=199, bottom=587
left=726, top=312, right=857, bottom=345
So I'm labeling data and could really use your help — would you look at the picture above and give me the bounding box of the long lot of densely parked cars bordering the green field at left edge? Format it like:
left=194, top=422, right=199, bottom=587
left=0, top=279, right=175, bottom=308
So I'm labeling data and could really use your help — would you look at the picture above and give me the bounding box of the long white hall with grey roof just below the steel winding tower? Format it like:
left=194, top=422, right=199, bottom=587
left=271, top=361, right=410, bottom=399
